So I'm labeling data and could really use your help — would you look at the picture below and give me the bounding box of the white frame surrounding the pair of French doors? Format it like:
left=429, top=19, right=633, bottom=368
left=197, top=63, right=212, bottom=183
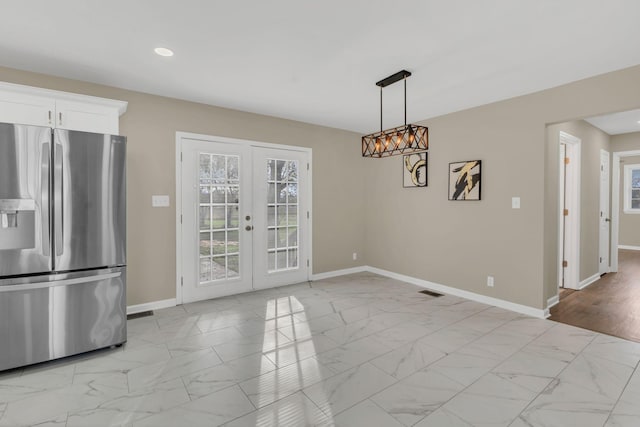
left=176, top=132, right=313, bottom=305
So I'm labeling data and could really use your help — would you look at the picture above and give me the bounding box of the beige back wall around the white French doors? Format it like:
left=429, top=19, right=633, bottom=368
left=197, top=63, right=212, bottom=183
left=0, top=68, right=365, bottom=305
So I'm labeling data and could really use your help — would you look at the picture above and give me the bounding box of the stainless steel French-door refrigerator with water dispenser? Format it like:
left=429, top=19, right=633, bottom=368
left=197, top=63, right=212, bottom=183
left=0, top=123, right=127, bottom=370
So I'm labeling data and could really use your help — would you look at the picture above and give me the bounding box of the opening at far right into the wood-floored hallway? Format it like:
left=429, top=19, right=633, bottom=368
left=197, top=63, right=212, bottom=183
left=548, top=110, right=640, bottom=342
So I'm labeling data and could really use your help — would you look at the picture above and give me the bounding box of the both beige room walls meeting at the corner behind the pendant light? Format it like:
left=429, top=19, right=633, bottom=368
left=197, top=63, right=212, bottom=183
left=0, top=62, right=640, bottom=309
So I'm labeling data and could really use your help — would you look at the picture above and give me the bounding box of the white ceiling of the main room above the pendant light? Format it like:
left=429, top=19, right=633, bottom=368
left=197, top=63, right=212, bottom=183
left=0, top=0, right=640, bottom=133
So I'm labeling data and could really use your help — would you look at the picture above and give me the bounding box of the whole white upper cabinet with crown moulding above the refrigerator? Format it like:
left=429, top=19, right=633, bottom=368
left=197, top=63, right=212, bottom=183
left=0, top=82, right=127, bottom=135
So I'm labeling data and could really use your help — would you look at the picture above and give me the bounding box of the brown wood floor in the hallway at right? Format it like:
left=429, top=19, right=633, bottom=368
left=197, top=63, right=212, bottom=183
left=549, top=250, right=640, bottom=342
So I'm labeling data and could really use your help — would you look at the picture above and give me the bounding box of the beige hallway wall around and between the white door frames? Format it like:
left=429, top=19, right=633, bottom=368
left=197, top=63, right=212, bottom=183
left=547, top=120, right=611, bottom=282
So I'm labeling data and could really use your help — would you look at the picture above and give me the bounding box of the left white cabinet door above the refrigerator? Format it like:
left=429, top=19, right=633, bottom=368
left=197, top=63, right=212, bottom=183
left=0, top=91, right=55, bottom=127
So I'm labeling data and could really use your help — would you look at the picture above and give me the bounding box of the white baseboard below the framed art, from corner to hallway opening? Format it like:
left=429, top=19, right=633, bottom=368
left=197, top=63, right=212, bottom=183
left=366, top=267, right=545, bottom=319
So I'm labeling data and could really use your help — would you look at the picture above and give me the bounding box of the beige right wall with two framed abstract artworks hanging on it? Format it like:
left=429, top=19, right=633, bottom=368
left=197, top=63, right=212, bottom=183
left=365, top=67, right=640, bottom=309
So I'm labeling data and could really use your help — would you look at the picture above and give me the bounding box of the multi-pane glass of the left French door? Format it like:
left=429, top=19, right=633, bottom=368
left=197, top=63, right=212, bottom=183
left=198, top=153, right=240, bottom=284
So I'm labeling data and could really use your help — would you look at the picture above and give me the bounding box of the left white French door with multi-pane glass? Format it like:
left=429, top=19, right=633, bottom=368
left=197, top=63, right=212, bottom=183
left=181, top=139, right=253, bottom=302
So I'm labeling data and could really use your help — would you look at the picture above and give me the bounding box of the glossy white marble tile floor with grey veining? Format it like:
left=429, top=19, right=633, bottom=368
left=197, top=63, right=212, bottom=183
left=0, top=273, right=640, bottom=427
